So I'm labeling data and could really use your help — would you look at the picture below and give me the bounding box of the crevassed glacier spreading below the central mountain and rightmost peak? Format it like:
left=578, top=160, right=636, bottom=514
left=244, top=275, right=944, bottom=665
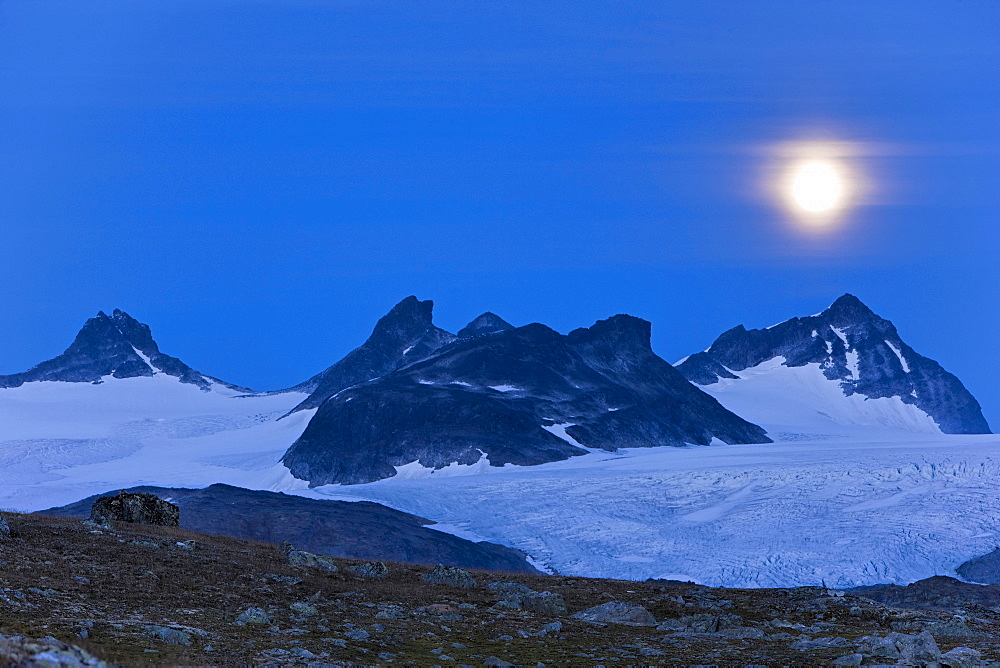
left=293, top=430, right=1000, bottom=587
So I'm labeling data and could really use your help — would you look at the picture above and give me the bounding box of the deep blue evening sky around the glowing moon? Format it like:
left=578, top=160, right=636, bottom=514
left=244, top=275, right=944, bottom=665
left=0, top=0, right=1000, bottom=427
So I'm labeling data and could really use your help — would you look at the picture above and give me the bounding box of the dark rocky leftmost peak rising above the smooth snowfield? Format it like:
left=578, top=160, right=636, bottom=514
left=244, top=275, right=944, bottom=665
left=0, top=309, right=252, bottom=392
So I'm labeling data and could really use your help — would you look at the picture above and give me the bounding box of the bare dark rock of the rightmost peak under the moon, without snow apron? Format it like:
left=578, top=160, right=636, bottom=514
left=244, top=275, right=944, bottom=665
left=677, top=294, right=990, bottom=434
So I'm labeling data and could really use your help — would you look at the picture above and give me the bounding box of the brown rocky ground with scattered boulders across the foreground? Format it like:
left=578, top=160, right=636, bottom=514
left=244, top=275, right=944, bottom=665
left=0, top=514, right=1000, bottom=668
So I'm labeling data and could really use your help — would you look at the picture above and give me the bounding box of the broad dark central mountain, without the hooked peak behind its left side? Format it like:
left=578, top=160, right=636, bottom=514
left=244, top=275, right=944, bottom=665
left=282, top=306, right=769, bottom=485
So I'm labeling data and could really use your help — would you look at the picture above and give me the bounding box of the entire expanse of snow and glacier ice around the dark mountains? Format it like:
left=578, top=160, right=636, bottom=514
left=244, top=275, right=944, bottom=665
left=0, top=374, right=1000, bottom=587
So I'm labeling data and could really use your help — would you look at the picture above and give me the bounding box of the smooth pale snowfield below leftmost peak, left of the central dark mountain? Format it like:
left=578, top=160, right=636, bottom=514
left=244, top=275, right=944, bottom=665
left=0, top=374, right=314, bottom=510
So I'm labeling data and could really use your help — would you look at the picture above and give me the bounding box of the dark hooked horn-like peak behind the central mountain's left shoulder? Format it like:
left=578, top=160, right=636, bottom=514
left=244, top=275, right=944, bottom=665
left=291, top=295, right=455, bottom=412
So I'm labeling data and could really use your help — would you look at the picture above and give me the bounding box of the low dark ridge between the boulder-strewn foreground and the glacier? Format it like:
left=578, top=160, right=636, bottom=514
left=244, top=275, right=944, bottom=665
left=41, top=484, right=538, bottom=573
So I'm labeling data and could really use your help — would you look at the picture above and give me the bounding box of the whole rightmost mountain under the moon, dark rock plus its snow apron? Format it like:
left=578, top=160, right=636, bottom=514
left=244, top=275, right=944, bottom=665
left=676, top=295, right=990, bottom=439
